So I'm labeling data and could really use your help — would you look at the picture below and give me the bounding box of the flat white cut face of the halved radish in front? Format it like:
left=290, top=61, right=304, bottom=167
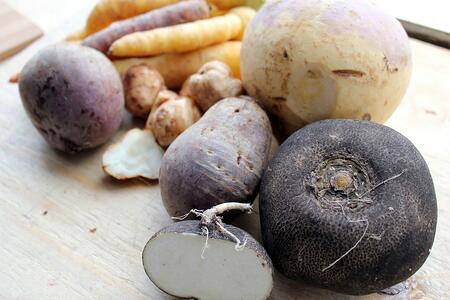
left=143, top=233, right=273, bottom=300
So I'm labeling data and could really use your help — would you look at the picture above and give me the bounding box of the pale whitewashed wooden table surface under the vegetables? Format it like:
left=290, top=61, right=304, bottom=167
left=0, top=1, right=450, bottom=300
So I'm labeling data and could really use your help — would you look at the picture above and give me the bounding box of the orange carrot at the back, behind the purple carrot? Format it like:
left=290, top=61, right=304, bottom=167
left=85, top=0, right=179, bottom=36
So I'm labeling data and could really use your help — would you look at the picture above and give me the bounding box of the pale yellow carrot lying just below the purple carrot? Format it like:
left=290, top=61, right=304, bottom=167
left=109, top=7, right=255, bottom=57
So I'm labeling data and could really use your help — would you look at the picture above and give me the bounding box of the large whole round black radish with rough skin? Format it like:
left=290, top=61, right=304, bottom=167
left=260, top=120, right=437, bottom=295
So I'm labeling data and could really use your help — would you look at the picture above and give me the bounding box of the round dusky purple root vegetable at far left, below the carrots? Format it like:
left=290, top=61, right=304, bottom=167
left=19, top=43, right=124, bottom=153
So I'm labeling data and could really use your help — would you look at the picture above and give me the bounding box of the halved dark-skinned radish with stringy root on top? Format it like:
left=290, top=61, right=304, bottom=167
left=142, top=203, right=273, bottom=300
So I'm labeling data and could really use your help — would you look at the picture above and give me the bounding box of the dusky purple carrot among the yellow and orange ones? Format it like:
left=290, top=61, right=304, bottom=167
left=83, top=0, right=209, bottom=53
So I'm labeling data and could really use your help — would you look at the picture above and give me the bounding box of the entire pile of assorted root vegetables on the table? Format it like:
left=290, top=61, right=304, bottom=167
left=14, top=0, right=437, bottom=300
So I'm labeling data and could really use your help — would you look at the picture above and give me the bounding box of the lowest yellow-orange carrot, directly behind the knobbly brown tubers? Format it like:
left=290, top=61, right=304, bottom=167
left=113, top=41, right=241, bottom=89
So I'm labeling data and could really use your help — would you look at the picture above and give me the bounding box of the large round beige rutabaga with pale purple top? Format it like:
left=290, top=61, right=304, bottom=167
left=241, top=0, right=412, bottom=132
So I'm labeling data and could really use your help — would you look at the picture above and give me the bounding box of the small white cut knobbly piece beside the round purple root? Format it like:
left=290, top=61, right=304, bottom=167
left=103, top=128, right=164, bottom=179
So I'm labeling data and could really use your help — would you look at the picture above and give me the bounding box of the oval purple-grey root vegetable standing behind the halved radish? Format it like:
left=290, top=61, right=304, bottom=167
left=159, top=97, right=272, bottom=216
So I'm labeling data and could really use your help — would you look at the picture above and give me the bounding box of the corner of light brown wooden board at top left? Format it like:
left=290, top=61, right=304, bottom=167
left=0, top=0, right=43, bottom=61
